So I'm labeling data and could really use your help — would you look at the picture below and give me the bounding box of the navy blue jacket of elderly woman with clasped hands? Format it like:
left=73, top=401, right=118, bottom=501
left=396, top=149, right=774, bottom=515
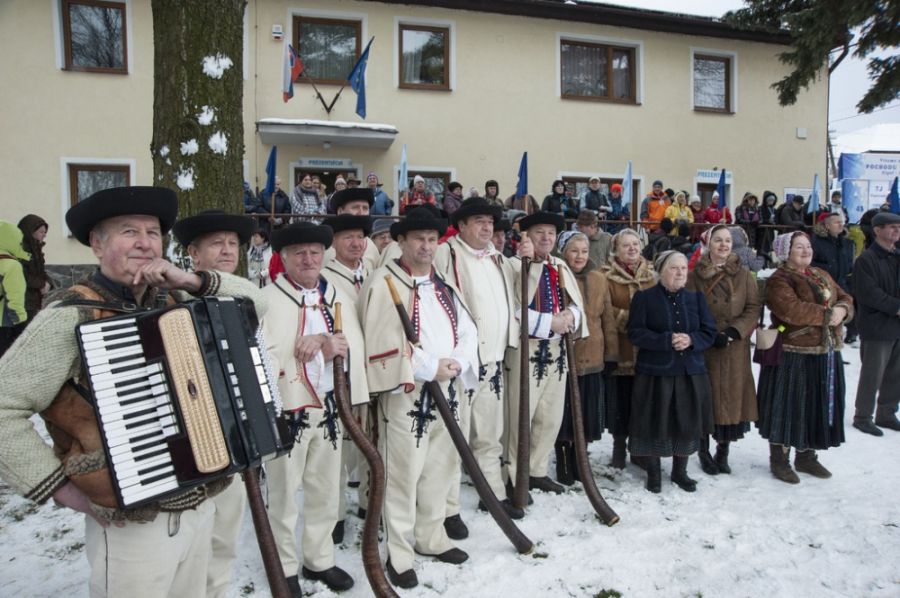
left=627, top=283, right=716, bottom=376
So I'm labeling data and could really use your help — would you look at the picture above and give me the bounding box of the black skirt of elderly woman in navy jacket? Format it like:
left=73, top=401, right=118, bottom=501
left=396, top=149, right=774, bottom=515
left=629, top=374, right=713, bottom=457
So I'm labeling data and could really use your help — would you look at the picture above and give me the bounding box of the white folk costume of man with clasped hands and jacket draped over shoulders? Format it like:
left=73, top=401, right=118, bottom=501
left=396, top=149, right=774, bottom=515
left=361, top=258, right=478, bottom=572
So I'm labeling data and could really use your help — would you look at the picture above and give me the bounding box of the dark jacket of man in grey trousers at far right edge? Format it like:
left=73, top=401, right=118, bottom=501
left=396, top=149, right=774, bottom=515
left=852, top=243, right=900, bottom=341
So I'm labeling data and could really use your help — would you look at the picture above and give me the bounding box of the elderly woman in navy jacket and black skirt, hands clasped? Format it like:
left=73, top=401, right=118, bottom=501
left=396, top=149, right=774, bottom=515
left=628, top=251, right=717, bottom=493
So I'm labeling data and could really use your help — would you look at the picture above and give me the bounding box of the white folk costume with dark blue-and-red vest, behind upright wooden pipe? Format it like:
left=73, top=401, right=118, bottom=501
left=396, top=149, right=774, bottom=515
left=506, top=256, right=588, bottom=481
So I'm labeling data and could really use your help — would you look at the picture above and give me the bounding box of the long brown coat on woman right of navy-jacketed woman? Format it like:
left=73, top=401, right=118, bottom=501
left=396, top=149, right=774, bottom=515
left=687, top=253, right=762, bottom=426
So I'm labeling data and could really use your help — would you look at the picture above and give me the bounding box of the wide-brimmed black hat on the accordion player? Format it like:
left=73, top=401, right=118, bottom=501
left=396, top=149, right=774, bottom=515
left=66, top=187, right=178, bottom=245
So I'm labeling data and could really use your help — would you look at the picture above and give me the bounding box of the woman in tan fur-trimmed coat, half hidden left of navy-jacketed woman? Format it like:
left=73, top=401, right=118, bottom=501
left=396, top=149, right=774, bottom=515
left=600, top=228, right=656, bottom=469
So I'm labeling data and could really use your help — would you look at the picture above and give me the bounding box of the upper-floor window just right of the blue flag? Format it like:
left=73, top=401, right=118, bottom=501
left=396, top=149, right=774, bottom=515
left=400, top=24, right=450, bottom=90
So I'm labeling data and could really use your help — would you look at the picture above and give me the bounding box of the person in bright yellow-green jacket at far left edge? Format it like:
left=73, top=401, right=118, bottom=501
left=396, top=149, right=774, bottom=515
left=0, top=220, right=31, bottom=356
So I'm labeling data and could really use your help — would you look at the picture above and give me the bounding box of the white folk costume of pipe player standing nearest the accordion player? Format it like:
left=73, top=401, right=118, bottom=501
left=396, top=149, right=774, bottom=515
left=263, top=273, right=369, bottom=577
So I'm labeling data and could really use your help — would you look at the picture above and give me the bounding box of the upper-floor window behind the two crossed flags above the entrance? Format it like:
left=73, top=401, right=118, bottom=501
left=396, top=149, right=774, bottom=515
left=294, top=16, right=362, bottom=85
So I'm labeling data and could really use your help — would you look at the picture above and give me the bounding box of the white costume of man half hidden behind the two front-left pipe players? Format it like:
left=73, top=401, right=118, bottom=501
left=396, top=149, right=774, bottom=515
left=322, top=254, right=377, bottom=519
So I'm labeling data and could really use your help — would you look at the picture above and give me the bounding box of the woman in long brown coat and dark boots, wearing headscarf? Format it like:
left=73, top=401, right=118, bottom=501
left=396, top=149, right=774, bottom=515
left=687, top=224, right=761, bottom=475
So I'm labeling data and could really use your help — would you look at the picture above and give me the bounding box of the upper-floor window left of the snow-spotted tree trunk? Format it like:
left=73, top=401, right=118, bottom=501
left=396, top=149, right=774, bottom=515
left=62, top=0, right=128, bottom=74
